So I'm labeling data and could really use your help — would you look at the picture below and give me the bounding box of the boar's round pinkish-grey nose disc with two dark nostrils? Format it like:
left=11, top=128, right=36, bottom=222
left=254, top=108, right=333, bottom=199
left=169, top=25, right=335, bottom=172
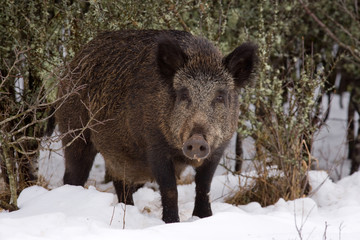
left=183, top=134, right=210, bottom=159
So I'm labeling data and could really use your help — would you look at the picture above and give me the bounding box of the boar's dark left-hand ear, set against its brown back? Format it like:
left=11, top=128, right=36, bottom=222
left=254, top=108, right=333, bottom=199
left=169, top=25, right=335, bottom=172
left=156, top=37, right=187, bottom=78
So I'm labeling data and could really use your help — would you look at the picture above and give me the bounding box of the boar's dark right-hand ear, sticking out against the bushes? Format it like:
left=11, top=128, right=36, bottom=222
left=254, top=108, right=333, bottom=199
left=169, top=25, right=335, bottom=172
left=223, top=43, right=257, bottom=88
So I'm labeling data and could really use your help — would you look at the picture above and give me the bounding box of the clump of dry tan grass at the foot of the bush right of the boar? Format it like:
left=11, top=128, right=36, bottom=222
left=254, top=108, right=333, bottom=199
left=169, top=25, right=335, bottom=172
left=226, top=136, right=317, bottom=207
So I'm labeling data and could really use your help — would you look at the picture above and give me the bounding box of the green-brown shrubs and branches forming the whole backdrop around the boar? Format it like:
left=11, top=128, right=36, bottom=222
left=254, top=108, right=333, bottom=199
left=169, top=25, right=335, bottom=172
left=0, top=0, right=360, bottom=210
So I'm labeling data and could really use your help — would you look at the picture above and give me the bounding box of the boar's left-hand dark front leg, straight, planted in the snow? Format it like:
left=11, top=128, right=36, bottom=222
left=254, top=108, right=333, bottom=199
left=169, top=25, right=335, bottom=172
left=148, top=142, right=180, bottom=223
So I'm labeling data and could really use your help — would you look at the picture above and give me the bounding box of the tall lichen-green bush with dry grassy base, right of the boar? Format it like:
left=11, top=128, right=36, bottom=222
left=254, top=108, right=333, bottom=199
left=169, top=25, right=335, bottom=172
left=228, top=0, right=326, bottom=206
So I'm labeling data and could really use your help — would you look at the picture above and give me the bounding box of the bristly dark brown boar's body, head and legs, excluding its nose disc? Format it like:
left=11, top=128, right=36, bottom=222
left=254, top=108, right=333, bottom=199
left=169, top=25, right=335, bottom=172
left=56, top=30, right=256, bottom=222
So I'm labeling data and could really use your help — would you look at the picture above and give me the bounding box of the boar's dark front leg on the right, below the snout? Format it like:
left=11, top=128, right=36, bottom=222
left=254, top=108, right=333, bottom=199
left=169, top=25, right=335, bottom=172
left=193, top=154, right=222, bottom=218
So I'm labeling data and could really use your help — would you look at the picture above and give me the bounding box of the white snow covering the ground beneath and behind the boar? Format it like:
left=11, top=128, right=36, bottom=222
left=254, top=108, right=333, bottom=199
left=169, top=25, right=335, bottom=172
left=0, top=93, right=360, bottom=240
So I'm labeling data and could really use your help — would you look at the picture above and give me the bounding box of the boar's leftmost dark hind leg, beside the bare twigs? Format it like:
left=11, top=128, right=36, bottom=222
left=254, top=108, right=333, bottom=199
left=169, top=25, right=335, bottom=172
left=63, top=131, right=97, bottom=186
